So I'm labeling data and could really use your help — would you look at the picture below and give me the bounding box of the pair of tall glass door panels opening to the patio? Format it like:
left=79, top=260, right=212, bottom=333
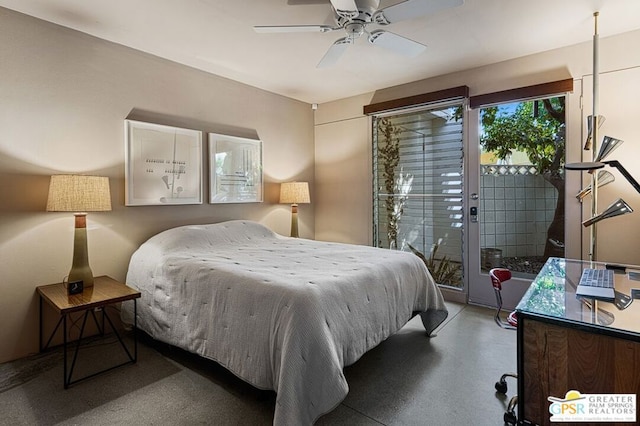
left=373, top=96, right=566, bottom=306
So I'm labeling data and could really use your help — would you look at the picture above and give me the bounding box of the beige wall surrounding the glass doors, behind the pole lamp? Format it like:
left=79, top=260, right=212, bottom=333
left=315, top=31, right=640, bottom=264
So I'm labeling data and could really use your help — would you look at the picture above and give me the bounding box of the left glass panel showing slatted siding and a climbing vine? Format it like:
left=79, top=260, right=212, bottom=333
left=373, top=101, right=464, bottom=290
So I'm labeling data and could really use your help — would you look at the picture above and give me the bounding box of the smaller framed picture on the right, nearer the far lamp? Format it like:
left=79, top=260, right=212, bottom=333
left=209, top=133, right=263, bottom=204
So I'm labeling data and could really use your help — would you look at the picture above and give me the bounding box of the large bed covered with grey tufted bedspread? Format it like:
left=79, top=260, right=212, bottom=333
left=122, top=220, right=447, bottom=425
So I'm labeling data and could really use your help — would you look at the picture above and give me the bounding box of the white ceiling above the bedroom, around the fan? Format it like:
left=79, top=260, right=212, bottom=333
left=0, top=0, right=640, bottom=103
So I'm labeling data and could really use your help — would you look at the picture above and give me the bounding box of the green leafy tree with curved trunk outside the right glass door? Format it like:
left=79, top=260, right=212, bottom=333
left=480, top=97, right=565, bottom=257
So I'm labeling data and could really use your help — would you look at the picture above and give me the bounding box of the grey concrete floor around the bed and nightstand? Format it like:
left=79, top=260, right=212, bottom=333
left=0, top=304, right=516, bottom=426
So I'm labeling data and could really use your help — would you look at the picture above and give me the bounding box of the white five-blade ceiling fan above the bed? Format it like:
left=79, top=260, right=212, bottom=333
left=253, top=0, right=464, bottom=68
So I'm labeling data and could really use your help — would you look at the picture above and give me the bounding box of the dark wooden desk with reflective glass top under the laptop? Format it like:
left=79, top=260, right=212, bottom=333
left=516, top=258, right=640, bottom=425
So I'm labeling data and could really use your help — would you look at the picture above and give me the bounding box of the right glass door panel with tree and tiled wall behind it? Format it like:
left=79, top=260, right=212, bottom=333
left=468, top=97, right=566, bottom=308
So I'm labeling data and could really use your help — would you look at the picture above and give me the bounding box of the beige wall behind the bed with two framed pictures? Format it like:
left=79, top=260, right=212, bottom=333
left=0, top=8, right=315, bottom=362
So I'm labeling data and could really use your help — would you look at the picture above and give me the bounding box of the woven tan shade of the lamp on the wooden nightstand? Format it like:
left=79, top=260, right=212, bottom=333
left=47, top=175, right=111, bottom=212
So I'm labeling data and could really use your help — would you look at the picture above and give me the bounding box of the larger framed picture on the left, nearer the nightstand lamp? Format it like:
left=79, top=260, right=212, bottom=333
left=125, top=120, right=203, bottom=206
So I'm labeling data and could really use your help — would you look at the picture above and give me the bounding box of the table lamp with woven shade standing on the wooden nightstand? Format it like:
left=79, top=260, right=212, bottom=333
left=47, top=175, right=111, bottom=288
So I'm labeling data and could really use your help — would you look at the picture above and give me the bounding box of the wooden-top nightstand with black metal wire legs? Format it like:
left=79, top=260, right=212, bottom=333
left=36, top=276, right=140, bottom=389
